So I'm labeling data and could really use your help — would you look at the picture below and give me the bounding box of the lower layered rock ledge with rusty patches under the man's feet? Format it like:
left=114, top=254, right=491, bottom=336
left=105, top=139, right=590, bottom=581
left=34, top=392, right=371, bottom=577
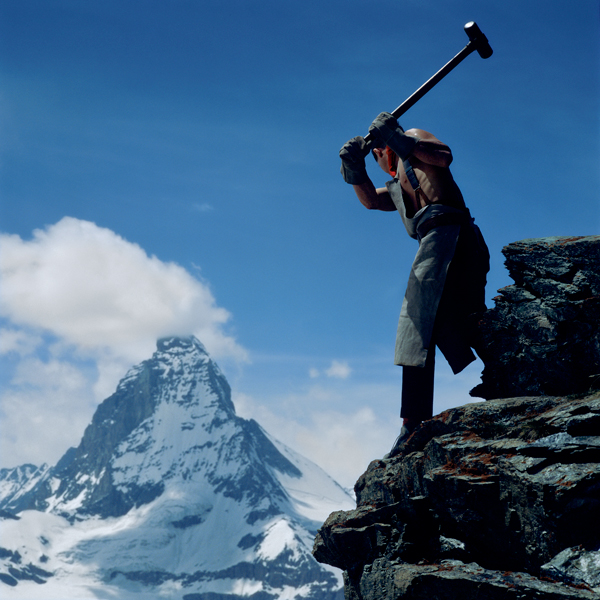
left=313, top=393, right=600, bottom=600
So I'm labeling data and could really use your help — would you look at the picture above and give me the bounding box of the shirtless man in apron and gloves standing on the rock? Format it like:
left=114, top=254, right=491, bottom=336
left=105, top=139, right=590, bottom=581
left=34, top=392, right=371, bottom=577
left=340, top=113, right=489, bottom=457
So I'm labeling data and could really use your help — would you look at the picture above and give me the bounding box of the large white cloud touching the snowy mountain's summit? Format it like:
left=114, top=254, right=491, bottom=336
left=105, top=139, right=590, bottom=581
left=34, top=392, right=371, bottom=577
left=0, top=217, right=246, bottom=360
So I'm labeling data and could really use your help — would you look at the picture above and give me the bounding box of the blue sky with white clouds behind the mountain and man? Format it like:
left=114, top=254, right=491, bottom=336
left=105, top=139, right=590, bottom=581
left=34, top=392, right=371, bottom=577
left=0, top=0, right=600, bottom=487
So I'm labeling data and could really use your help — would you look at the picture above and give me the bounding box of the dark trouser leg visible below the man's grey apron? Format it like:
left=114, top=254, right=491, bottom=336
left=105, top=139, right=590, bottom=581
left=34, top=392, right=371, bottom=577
left=400, top=344, right=435, bottom=421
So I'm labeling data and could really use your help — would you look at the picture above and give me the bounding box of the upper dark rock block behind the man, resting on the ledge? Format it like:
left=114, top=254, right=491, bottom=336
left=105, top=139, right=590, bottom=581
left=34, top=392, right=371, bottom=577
left=471, top=236, right=600, bottom=399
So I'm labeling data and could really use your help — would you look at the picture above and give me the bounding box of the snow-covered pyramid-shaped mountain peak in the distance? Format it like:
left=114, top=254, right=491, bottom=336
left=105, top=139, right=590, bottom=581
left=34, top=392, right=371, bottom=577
left=0, top=337, right=354, bottom=600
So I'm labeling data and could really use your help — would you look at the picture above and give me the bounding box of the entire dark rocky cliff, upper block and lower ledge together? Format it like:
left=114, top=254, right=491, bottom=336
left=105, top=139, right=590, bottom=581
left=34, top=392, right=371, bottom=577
left=313, top=237, right=600, bottom=600
